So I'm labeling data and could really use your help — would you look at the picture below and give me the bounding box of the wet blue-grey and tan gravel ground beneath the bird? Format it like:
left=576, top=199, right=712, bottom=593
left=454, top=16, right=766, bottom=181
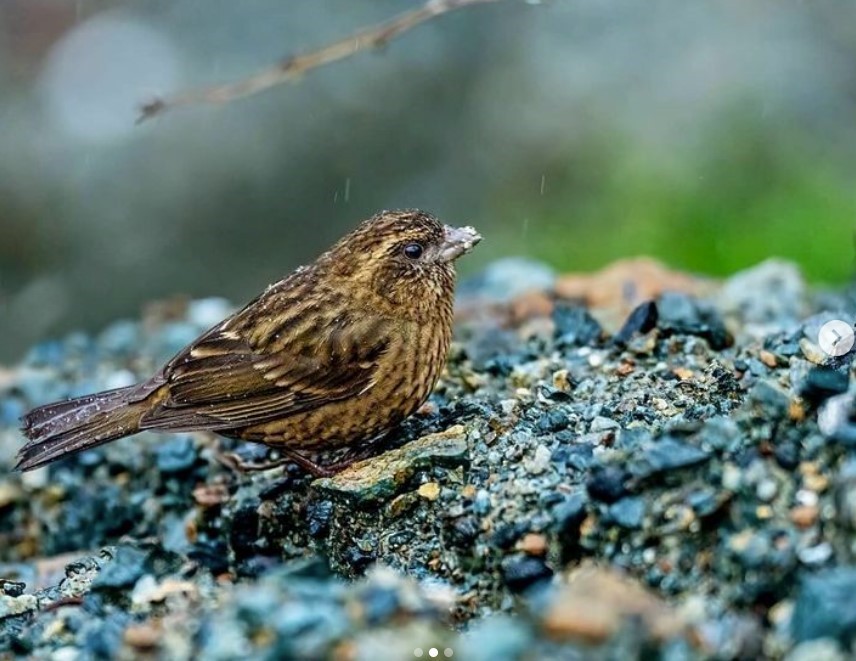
left=0, top=260, right=856, bottom=661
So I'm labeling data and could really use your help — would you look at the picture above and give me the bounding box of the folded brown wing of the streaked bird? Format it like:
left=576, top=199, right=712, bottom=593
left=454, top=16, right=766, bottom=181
left=142, top=296, right=390, bottom=431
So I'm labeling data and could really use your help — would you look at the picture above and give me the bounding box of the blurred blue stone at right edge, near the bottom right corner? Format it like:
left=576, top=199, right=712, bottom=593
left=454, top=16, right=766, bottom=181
left=791, top=567, right=856, bottom=646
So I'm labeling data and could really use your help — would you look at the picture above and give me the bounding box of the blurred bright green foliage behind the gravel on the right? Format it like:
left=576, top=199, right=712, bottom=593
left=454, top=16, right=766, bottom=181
left=494, top=103, right=856, bottom=284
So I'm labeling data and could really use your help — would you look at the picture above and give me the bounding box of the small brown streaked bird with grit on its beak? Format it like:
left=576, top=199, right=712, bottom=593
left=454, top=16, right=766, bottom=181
left=17, top=210, right=481, bottom=474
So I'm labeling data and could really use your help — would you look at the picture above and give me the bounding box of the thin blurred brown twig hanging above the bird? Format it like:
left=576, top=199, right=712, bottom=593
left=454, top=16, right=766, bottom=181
left=137, top=0, right=499, bottom=123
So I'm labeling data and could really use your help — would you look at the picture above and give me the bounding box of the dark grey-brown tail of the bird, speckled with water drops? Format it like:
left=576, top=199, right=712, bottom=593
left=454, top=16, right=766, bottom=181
left=15, top=386, right=148, bottom=471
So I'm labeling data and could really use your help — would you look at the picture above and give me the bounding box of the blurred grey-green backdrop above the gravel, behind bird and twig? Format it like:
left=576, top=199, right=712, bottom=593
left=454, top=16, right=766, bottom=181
left=0, top=0, right=856, bottom=363
